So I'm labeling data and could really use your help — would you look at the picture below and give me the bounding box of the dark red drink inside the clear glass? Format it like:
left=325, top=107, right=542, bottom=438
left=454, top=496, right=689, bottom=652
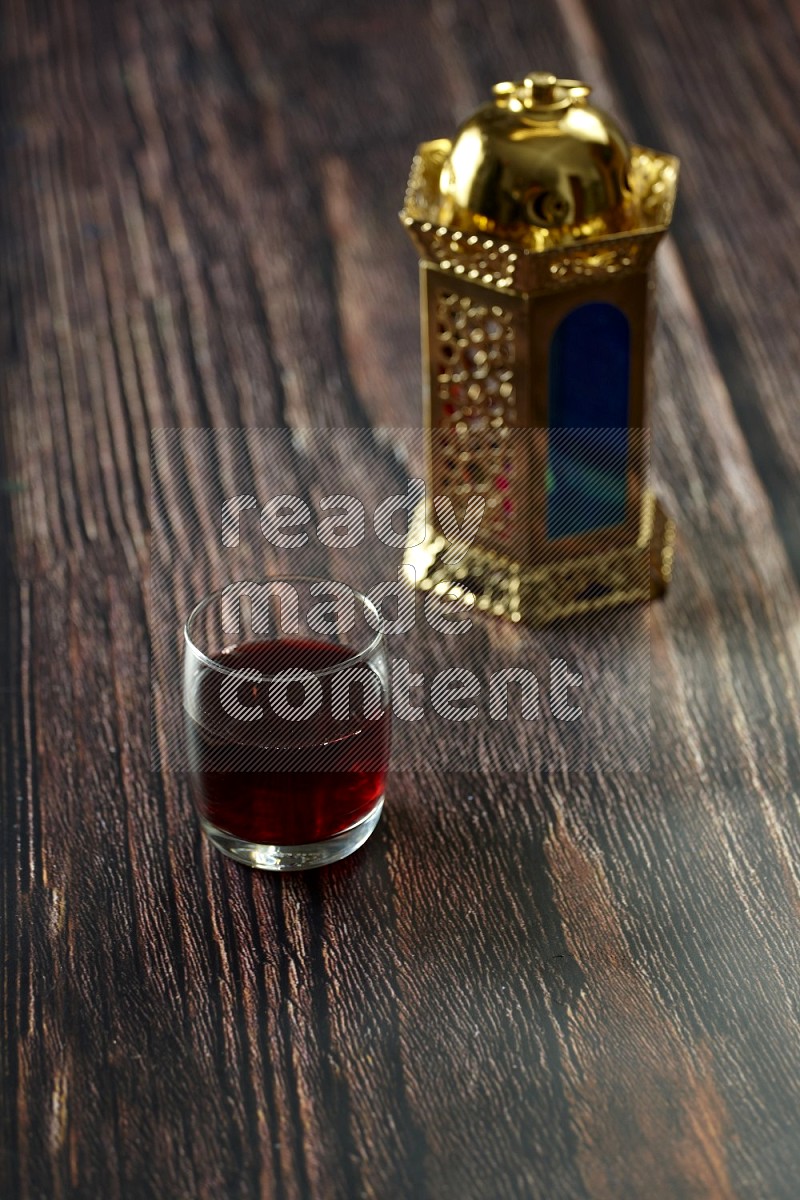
left=187, top=638, right=390, bottom=845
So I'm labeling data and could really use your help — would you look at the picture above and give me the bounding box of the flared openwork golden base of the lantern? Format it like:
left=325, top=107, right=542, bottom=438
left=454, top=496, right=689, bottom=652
left=404, top=492, right=675, bottom=626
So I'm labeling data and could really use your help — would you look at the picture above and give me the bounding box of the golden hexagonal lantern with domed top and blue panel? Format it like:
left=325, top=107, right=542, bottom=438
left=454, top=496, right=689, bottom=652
left=401, top=73, right=678, bottom=625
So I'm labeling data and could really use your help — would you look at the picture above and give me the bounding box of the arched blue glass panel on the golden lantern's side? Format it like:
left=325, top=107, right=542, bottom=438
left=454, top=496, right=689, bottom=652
left=547, top=304, right=631, bottom=540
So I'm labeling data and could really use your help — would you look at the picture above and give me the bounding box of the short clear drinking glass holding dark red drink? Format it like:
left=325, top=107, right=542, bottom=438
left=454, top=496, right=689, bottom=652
left=184, top=576, right=391, bottom=871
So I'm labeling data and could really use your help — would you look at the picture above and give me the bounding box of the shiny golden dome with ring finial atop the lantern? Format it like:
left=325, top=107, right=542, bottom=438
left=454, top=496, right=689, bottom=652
left=439, top=72, right=638, bottom=250
